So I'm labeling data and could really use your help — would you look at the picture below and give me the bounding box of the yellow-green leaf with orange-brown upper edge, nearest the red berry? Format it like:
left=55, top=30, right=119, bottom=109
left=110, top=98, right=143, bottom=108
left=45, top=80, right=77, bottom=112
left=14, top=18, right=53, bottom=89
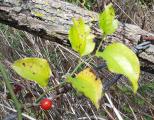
left=67, top=68, right=103, bottom=109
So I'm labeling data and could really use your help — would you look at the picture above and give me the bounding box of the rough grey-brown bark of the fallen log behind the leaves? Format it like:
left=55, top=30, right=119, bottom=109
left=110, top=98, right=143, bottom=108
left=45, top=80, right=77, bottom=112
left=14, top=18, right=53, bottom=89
left=0, top=0, right=154, bottom=63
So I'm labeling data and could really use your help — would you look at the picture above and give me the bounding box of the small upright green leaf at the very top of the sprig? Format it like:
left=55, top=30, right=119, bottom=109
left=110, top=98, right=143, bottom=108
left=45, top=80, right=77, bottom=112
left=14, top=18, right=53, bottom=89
left=99, top=3, right=118, bottom=35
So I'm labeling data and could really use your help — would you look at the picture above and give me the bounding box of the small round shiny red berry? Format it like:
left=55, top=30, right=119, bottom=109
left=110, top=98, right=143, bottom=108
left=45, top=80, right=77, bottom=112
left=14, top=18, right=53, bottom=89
left=40, top=98, right=52, bottom=110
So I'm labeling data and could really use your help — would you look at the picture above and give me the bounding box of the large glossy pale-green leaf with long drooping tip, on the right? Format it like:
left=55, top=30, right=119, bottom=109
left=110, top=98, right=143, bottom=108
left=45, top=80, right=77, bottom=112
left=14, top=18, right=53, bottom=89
left=96, top=43, right=140, bottom=93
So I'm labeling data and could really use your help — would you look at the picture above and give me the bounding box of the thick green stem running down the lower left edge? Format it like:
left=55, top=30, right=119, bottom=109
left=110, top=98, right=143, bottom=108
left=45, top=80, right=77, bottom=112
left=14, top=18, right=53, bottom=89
left=0, top=62, right=22, bottom=120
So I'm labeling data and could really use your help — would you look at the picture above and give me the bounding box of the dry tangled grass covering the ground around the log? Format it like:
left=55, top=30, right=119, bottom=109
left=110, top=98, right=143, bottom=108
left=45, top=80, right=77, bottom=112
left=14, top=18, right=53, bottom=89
left=0, top=1, right=154, bottom=120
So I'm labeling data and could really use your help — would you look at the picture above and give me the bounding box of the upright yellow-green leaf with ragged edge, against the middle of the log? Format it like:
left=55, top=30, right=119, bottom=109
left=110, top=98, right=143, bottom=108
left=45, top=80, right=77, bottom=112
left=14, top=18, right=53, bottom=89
left=69, top=18, right=95, bottom=56
